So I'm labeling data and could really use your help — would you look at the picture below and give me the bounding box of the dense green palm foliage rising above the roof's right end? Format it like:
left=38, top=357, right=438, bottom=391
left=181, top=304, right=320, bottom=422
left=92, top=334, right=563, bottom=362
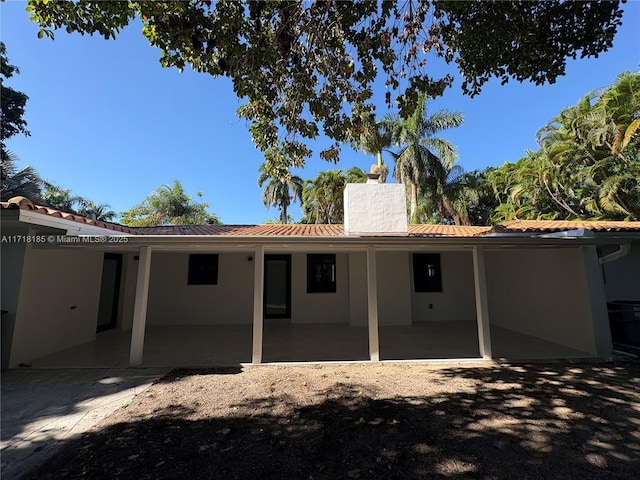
left=487, top=72, right=640, bottom=221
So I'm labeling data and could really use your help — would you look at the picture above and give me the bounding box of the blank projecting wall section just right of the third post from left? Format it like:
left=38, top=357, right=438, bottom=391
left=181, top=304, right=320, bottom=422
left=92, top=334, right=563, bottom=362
left=377, top=252, right=411, bottom=327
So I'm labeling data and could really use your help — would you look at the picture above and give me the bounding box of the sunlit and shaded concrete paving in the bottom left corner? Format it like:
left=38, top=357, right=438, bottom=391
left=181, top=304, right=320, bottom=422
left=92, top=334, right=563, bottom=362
left=0, top=368, right=170, bottom=480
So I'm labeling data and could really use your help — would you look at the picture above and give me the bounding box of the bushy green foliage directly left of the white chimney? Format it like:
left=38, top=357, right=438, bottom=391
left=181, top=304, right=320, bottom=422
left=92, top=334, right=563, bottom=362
left=300, top=167, right=367, bottom=224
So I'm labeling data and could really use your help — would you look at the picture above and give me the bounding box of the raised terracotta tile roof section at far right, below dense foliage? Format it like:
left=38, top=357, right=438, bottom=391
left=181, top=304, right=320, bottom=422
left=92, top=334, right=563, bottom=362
left=495, top=220, right=640, bottom=233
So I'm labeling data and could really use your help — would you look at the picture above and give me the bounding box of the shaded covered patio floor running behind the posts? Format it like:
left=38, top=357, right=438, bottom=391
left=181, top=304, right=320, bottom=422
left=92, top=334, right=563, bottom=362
left=18, top=322, right=591, bottom=368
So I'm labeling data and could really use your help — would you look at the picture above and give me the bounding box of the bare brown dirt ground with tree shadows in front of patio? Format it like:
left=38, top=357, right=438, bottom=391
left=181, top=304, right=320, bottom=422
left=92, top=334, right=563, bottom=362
left=25, top=363, right=640, bottom=480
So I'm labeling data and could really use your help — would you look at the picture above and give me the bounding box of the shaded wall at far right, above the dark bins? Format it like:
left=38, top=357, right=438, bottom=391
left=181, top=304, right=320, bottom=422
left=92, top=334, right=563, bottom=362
left=602, top=242, right=640, bottom=302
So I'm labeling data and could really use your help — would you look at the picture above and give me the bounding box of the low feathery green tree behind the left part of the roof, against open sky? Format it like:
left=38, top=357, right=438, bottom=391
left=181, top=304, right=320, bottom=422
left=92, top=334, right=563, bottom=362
left=121, top=180, right=221, bottom=227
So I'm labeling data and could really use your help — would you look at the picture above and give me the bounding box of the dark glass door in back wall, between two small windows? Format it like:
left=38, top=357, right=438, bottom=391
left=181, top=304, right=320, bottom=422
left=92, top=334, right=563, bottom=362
left=263, top=255, right=291, bottom=318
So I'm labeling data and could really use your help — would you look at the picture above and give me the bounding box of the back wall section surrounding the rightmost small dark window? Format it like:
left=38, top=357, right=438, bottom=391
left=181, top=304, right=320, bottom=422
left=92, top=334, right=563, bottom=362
left=410, top=252, right=476, bottom=322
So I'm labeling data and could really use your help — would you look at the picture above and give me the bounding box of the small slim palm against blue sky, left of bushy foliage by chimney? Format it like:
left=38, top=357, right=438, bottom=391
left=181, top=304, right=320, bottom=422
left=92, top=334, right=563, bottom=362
left=258, top=162, right=304, bottom=223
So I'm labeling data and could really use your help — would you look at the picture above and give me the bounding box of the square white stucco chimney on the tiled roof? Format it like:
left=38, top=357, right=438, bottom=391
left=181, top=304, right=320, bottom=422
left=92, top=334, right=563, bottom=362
left=344, top=179, right=408, bottom=236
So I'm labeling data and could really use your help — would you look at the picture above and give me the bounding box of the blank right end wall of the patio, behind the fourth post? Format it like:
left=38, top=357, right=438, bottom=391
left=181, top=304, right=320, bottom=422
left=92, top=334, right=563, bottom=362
left=485, top=247, right=596, bottom=355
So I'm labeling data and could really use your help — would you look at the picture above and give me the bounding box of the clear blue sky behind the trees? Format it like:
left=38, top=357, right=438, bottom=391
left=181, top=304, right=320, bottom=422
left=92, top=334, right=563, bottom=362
left=0, top=0, right=640, bottom=224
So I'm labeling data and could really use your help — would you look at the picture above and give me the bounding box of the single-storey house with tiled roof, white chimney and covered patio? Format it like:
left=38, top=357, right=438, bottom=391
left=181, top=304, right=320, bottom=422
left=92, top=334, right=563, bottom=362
left=1, top=184, right=640, bottom=368
